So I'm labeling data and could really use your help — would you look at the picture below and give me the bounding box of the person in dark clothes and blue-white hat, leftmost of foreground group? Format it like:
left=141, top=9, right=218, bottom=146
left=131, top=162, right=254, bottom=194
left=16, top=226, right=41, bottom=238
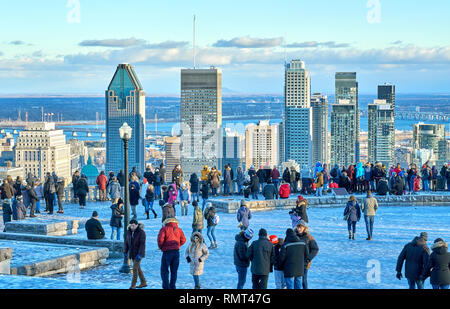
left=233, top=229, right=253, bottom=290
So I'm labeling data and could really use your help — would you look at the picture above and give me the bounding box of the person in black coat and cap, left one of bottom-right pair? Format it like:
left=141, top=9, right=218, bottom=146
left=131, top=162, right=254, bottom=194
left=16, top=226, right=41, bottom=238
left=396, top=232, right=430, bottom=289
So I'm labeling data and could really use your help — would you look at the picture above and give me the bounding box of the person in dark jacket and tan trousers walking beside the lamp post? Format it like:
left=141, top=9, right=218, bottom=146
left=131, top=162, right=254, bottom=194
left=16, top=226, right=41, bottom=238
left=123, top=219, right=147, bottom=289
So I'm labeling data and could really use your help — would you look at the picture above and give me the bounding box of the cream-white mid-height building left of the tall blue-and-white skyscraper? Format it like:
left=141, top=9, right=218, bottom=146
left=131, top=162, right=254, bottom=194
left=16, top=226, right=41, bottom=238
left=245, top=120, right=280, bottom=169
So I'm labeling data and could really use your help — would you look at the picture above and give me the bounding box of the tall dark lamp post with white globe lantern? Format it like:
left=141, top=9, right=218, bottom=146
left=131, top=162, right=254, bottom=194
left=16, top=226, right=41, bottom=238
left=119, top=122, right=133, bottom=274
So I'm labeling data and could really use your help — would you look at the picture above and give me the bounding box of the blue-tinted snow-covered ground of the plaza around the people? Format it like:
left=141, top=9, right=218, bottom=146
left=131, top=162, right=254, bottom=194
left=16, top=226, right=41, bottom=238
left=0, top=199, right=450, bottom=289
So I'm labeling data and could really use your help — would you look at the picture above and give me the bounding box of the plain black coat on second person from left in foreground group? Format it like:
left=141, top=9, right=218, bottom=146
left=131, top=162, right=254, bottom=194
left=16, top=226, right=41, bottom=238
left=247, top=236, right=274, bottom=276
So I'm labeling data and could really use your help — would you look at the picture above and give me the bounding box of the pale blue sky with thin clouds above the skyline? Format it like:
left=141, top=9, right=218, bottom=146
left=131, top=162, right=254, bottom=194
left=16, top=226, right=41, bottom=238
left=0, top=0, right=450, bottom=96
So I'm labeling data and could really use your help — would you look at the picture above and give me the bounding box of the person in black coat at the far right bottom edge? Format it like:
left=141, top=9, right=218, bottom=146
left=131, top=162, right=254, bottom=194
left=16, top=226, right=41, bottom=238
left=420, top=238, right=450, bottom=289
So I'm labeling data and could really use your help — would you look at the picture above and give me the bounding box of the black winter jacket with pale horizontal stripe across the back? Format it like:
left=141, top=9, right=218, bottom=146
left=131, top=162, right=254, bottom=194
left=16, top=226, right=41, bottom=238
left=280, top=229, right=309, bottom=278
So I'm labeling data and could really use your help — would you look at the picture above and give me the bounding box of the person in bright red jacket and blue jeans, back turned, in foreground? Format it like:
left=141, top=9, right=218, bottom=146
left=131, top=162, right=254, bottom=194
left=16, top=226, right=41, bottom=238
left=158, top=218, right=186, bottom=289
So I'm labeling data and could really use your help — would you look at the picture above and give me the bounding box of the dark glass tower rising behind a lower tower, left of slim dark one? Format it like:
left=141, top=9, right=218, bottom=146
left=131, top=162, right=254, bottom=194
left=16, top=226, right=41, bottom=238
left=334, top=72, right=360, bottom=162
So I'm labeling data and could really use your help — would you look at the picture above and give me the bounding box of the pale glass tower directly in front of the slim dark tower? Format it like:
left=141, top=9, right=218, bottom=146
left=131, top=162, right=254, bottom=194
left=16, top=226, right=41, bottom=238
left=367, top=100, right=395, bottom=166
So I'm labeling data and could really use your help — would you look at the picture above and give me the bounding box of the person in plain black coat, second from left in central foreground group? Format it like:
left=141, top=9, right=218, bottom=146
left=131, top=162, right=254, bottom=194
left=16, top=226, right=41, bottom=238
left=247, top=229, right=274, bottom=289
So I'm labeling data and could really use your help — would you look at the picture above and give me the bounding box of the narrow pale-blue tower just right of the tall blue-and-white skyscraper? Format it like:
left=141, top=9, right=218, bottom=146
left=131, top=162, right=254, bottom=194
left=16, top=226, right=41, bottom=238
left=311, top=93, right=330, bottom=163
